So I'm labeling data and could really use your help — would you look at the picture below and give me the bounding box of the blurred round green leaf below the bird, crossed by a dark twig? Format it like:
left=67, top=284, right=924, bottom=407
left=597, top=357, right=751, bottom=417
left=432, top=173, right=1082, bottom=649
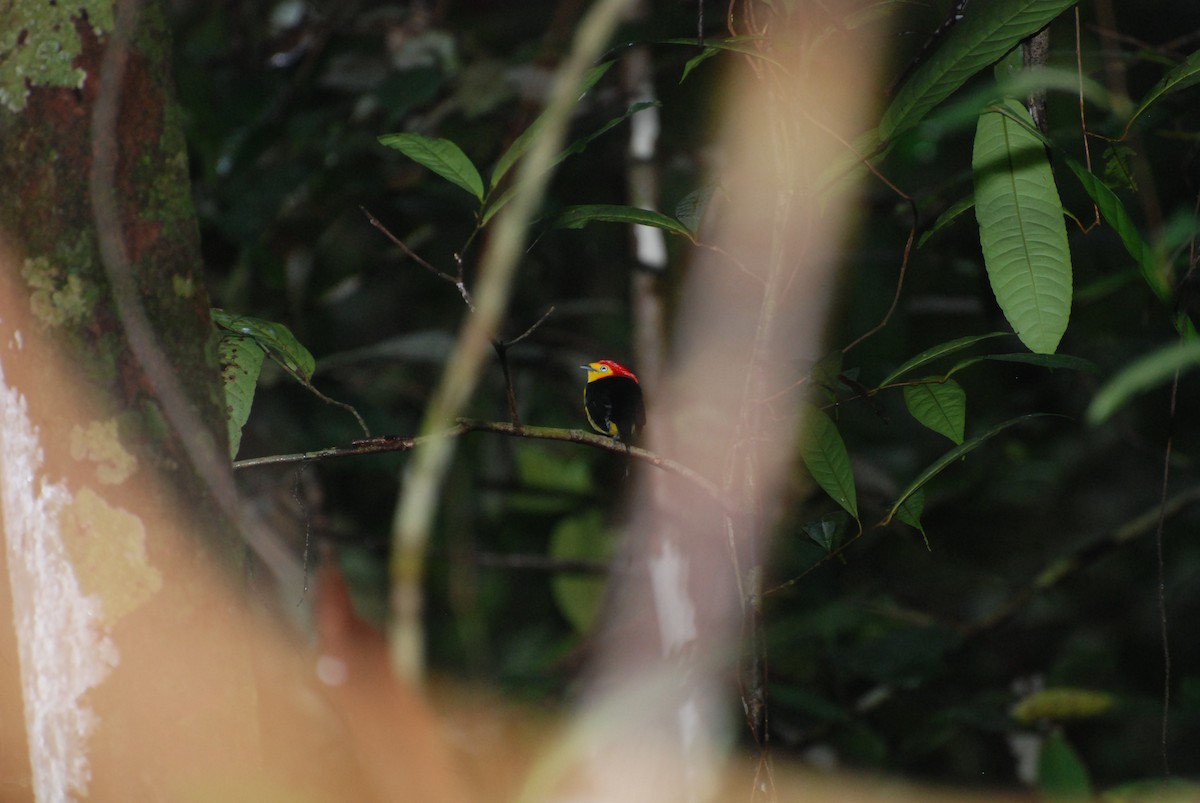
left=550, top=510, right=613, bottom=634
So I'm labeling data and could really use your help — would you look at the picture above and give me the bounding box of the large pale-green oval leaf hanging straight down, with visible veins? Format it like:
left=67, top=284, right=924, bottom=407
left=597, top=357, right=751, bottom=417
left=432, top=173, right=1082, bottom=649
left=971, top=98, right=1072, bottom=354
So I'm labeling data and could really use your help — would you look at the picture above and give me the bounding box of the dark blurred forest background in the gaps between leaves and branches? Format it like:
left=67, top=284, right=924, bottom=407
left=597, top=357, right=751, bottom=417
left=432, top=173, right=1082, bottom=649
left=170, top=0, right=1200, bottom=786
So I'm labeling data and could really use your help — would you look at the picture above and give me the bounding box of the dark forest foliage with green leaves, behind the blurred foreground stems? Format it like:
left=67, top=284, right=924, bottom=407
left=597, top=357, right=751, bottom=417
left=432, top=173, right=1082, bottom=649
left=173, top=0, right=1200, bottom=799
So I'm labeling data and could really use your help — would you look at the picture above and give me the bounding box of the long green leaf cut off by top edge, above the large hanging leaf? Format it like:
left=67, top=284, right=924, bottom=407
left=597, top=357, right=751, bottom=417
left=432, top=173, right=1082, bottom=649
left=878, top=0, right=1075, bottom=142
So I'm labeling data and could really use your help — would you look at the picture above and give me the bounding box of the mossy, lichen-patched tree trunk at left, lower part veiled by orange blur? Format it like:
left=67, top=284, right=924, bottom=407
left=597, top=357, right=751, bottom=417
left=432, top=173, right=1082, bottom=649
left=0, top=0, right=259, bottom=799
